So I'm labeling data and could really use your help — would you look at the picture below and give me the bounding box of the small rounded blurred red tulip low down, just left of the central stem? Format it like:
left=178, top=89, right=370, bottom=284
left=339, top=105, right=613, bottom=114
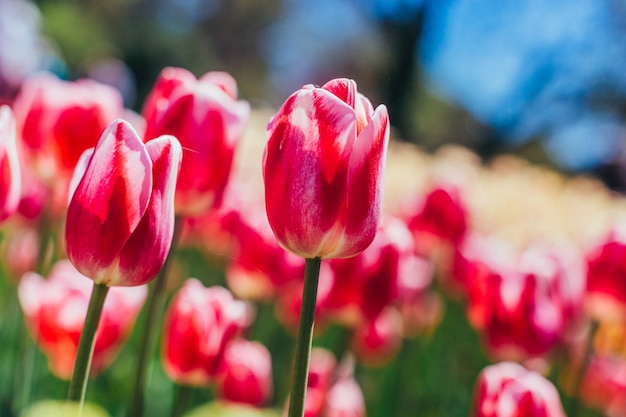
left=218, top=339, right=272, bottom=407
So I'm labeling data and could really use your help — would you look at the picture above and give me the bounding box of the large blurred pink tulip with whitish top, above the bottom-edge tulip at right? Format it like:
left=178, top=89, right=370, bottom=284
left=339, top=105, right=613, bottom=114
left=460, top=239, right=585, bottom=360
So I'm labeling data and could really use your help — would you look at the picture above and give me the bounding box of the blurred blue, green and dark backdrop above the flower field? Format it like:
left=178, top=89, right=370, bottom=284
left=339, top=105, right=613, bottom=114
left=0, top=0, right=626, bottom=184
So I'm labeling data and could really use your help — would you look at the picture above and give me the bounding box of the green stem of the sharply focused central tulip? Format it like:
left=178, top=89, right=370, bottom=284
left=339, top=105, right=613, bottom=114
left=288, top=258, right=322, bottom=417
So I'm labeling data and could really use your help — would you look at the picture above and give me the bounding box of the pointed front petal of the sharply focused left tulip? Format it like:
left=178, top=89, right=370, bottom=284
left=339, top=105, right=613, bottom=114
left=65, top=120, right=152, bottom=283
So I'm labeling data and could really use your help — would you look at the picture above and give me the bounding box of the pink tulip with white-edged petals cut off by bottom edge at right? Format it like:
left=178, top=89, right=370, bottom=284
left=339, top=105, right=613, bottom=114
left=471, top=362, right=566, bottom=417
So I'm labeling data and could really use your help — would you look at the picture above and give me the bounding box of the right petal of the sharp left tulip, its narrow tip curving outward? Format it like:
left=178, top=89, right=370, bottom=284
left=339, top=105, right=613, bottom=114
left=114, top=135, right=182, bottom=286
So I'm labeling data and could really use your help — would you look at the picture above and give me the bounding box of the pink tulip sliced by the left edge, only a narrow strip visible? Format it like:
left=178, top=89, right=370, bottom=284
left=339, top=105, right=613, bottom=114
left=0, top=106, right=22, bottom=221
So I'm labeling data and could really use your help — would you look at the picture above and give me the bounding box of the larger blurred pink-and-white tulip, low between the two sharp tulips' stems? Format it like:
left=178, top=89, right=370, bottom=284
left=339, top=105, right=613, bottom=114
left=162, top=278, right=250, bottom=386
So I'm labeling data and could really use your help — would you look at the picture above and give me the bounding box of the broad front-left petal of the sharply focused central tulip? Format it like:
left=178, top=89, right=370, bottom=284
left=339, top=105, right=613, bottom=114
left=263, top=89, right=356, bottom=257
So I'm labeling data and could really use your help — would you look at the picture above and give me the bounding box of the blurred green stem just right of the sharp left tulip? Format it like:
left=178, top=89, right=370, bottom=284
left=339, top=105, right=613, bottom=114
left=127, top=217, right=183, bottom=417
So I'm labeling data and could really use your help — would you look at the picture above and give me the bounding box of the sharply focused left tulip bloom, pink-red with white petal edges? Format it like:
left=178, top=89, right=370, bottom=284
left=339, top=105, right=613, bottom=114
left=65, top=120, right=181, bottom=286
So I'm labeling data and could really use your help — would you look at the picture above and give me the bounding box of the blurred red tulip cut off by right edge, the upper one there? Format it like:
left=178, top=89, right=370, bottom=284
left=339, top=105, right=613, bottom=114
left=585, top=228, right=626, bottom=321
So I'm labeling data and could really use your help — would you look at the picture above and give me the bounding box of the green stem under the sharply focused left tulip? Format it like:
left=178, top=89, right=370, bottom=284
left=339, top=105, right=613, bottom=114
left=67, top=283, right=109, bottom=408
